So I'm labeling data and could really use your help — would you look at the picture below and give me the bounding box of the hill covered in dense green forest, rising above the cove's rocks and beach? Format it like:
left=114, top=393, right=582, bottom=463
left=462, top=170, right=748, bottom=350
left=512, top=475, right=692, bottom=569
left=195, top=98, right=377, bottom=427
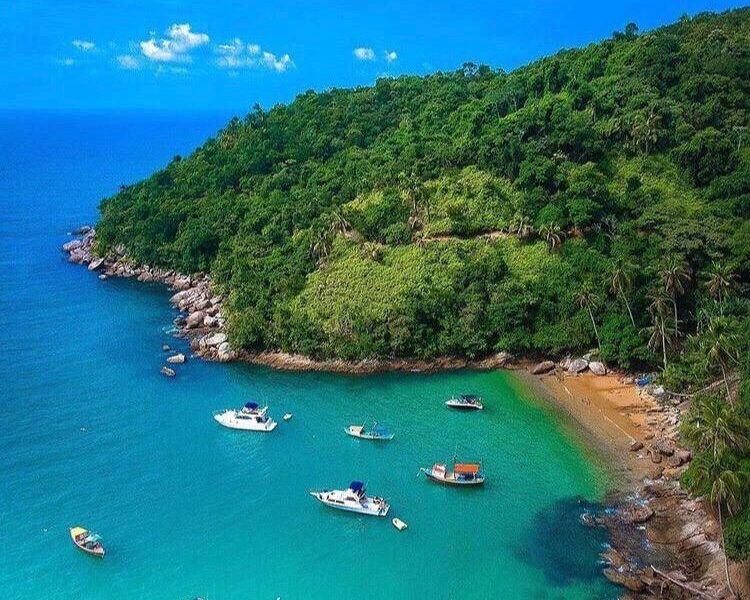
left=97, top=9, right=750, bottom=368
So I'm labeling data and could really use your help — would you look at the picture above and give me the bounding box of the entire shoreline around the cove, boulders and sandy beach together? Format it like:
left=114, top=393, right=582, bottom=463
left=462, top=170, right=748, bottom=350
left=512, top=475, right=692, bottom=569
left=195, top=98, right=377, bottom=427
left=63, top=227, right=741, bottom=599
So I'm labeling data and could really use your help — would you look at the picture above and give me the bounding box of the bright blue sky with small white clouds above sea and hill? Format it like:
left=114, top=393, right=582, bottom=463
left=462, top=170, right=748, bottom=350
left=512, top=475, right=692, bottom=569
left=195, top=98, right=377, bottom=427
left=0, top=0, right=743, bottom=114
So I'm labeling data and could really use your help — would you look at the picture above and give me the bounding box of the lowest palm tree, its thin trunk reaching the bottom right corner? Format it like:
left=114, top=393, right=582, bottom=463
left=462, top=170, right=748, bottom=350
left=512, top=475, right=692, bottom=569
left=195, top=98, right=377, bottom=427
left=693, top=454, right=742, bottom=599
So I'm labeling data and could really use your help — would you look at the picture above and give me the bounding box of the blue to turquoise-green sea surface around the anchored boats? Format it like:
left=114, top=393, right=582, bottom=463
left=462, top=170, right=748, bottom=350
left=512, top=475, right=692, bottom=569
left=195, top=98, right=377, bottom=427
left=0, top=112, right=617, bottom=600
